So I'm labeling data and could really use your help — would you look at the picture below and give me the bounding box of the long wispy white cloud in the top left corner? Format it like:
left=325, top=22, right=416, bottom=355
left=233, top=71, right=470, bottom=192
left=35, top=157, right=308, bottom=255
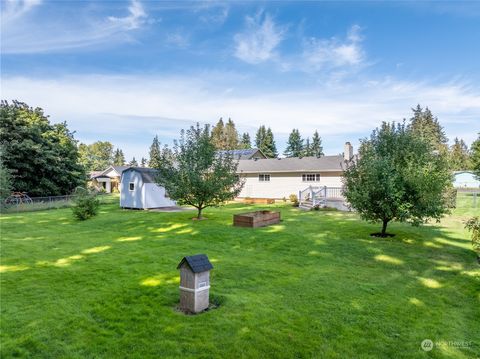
left=2, top=0, right=147, bottom=54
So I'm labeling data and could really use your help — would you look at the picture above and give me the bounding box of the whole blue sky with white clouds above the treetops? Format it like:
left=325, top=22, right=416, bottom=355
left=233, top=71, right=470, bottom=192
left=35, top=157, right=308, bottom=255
left=1, top=0, right=480, bottom=159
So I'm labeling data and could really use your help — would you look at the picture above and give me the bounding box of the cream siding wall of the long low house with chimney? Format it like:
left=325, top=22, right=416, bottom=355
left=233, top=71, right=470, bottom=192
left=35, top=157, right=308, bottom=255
left=239, top=172, right=342, bottom=199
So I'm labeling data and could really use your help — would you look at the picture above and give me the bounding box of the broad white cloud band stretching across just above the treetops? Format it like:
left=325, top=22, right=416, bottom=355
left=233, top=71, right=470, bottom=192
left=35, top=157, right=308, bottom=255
left=2, top=73, right=480, bottom=161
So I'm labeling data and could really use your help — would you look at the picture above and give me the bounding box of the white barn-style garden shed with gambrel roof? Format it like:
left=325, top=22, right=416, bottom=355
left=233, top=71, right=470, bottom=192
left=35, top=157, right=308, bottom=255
left=120, top=167, right=176, bottom=209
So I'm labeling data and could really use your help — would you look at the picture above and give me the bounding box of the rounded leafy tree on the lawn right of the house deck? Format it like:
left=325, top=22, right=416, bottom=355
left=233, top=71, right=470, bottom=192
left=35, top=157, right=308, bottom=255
left=343, top=122, right=452, bottom=237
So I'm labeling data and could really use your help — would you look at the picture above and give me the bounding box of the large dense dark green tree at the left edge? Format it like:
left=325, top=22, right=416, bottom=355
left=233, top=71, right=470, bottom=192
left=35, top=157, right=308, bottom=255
left=0, top=101, right=86, bottom=196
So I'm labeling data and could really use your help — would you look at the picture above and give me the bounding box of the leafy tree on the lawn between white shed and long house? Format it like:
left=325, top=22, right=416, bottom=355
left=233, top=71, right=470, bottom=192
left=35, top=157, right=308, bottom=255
left=157, top=123, right=243, bottom=219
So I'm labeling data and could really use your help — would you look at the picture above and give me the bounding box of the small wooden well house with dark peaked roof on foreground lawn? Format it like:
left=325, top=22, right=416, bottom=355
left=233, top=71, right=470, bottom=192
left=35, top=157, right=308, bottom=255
left=177, top=254, right=213, bottom=313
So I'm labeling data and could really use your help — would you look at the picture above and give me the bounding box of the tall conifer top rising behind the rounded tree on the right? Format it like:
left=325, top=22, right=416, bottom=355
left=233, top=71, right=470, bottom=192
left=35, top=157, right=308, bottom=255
left=408, top=105, right=448, bottom=153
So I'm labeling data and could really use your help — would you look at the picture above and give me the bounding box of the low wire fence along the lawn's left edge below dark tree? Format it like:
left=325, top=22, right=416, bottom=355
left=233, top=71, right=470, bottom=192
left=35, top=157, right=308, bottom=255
left=1, top=193, right=111, bottom=213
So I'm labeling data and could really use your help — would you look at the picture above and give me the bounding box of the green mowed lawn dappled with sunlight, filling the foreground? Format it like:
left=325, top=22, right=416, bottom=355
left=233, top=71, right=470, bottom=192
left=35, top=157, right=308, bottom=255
left=0, top=198, right=480, bottom=358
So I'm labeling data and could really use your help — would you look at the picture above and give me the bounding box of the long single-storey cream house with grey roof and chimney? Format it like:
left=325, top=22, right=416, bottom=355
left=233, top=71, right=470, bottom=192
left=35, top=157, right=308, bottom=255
left=237, top=142, right=353, bottom=199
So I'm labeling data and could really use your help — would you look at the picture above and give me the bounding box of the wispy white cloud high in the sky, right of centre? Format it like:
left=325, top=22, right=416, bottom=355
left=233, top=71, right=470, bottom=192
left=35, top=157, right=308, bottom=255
left=303, top=25, right=365, bottom=71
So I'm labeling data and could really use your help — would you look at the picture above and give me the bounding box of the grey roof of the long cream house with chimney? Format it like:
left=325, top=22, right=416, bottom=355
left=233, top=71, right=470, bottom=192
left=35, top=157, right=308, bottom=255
left=237, top=155, right=344, bottom=173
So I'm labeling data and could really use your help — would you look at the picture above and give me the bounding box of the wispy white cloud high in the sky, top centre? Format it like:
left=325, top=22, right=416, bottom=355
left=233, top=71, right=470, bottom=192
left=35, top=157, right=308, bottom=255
left=234, top=12, right=286, bottom=64
